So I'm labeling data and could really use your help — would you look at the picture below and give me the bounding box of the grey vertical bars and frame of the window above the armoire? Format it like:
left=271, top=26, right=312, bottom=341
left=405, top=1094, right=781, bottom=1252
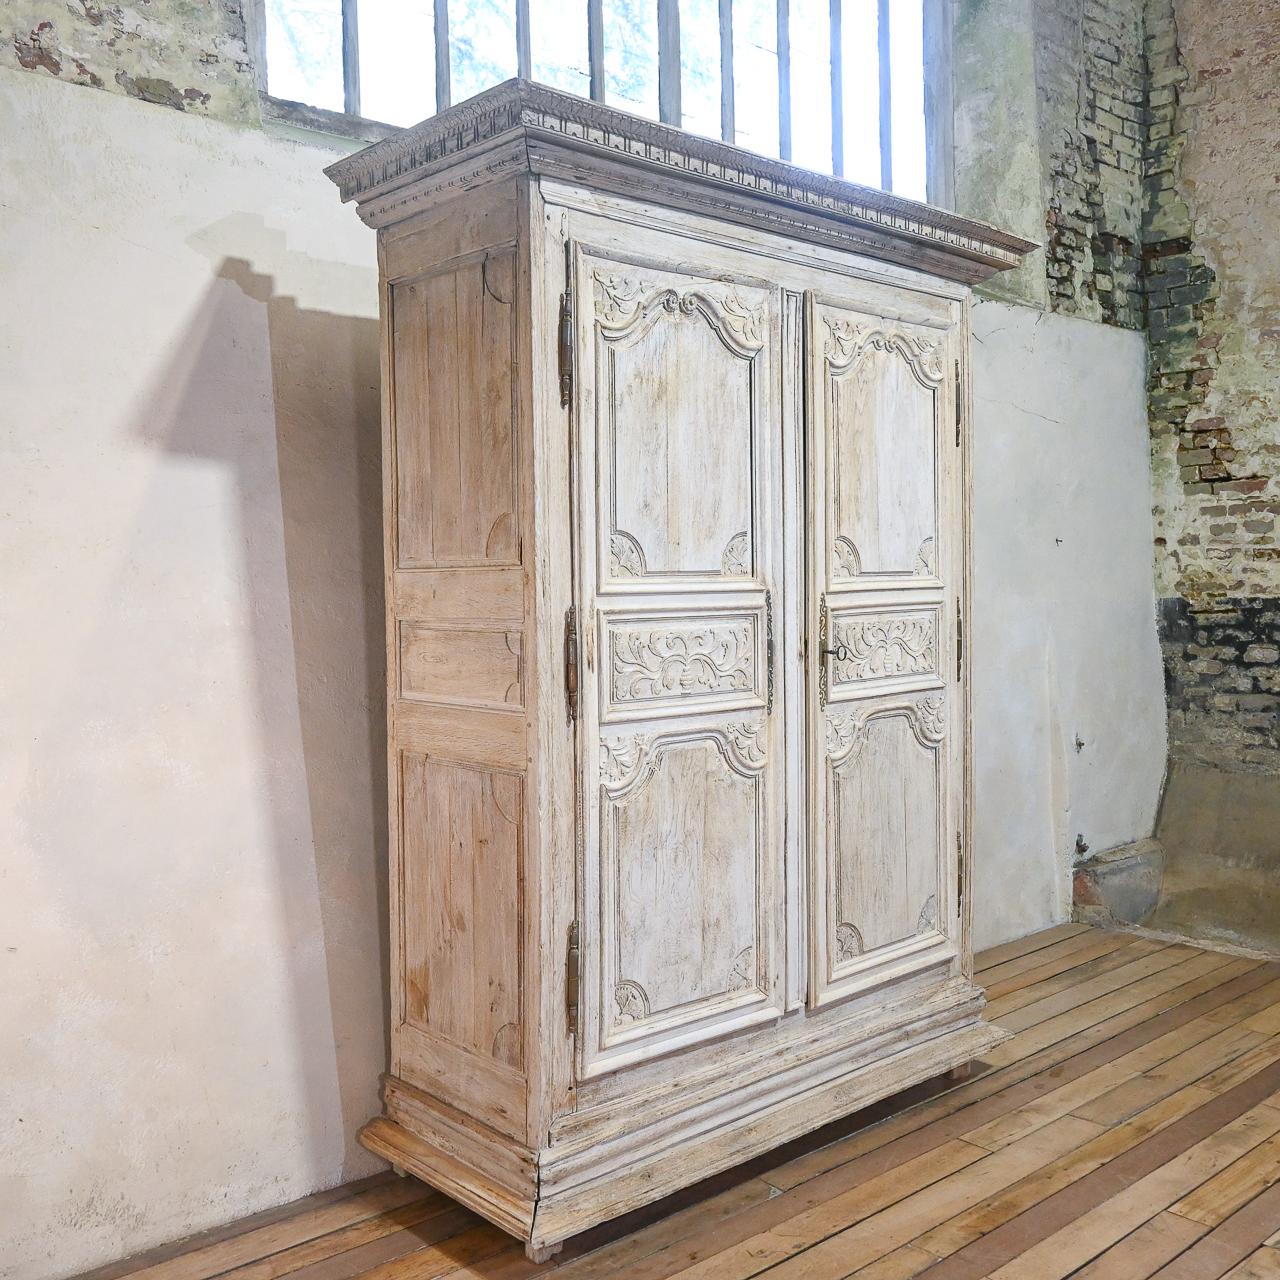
left=244, top=0, right=955, bottom=209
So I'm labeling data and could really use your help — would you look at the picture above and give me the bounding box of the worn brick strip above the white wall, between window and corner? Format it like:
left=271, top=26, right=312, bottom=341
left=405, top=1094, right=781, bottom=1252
left=1036, top=0, right=1146, bottom=329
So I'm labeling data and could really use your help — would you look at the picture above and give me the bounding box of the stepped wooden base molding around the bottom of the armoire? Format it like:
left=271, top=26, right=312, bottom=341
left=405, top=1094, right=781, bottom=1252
left=360, top=1020, right=1009, bottom=1251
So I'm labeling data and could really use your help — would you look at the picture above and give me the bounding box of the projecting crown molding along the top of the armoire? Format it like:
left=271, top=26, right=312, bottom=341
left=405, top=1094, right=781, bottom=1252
left=325, top=79, right=1038, bottom=283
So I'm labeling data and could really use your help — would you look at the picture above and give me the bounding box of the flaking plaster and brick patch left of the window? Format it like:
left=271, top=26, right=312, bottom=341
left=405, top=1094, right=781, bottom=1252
left=0, top=0, right=260, bottom=124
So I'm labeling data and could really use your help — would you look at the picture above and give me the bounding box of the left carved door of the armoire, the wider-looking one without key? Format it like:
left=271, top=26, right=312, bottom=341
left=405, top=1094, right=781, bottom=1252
left=572, top=240, right=786, bottom=1076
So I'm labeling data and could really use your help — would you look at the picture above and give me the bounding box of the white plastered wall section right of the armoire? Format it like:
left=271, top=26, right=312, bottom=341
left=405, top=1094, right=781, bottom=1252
left=973, top=302, right=1165, bottom=947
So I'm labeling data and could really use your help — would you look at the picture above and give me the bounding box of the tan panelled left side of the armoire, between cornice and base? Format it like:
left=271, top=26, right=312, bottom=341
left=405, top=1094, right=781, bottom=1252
left=381, top=175, right=530, bottom=1138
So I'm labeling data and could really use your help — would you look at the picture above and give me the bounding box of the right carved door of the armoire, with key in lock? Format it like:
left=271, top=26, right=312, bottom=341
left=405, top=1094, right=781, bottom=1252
left=806, top=296, right=963, bottom=1005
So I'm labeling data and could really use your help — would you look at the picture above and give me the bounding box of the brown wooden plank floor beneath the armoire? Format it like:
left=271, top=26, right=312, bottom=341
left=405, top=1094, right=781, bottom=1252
left=82, top=924, right=1280, bottom=1280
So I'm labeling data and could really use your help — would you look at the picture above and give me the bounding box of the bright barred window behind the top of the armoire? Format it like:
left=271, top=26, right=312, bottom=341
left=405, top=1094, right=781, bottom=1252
left=262, top=0, right=929, bottom=200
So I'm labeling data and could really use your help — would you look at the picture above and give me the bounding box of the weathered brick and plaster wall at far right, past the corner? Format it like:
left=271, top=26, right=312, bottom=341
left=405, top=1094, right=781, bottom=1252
left=1143, top=0, right=1280, bottom=772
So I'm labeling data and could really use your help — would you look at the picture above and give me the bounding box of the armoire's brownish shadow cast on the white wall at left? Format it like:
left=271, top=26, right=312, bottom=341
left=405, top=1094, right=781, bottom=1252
left=148, top=216, right=389, bottom=1176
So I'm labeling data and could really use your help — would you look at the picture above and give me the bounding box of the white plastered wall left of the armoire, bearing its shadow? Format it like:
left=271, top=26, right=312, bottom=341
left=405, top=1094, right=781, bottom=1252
left=0, top=70, right=385, bottom=1280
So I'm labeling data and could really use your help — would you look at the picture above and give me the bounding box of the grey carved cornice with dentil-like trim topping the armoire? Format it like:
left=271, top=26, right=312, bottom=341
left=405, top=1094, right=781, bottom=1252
left=325, top=79, right=1037, bottom=275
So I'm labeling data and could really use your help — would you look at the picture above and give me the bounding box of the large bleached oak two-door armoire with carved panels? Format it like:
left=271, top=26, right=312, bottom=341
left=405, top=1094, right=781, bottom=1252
left=328, top=81, right=1029, bottom=1256
